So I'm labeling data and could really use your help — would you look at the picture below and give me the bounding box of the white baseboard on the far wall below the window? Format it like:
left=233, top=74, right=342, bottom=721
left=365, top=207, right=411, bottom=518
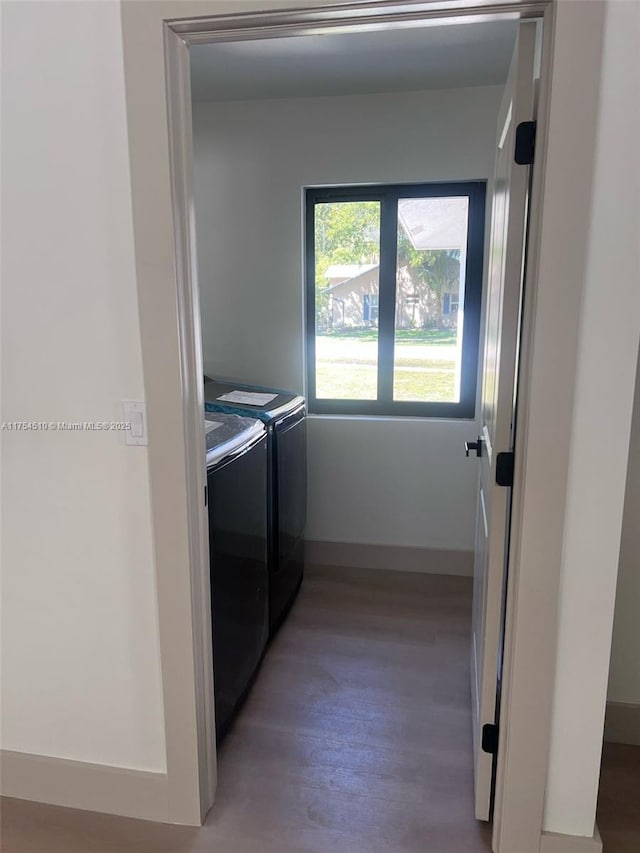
left=305, top=539, right=473, bottom=577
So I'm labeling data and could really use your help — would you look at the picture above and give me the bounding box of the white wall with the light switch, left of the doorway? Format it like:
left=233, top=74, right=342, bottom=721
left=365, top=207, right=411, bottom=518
left=2, top=2, right=165, bottom=771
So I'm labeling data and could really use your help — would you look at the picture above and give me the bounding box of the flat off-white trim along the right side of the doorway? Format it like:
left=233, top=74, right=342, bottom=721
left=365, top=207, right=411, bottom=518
left=493, top=3, right=605, bottom=851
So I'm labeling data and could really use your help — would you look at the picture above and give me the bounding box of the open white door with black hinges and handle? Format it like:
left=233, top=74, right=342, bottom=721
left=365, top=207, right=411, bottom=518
left=471, top=22, right=536, bottom=820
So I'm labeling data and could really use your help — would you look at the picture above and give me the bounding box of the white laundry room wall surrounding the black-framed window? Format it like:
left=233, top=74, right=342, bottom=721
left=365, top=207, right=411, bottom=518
left=194, top=87, right=501, bottom=550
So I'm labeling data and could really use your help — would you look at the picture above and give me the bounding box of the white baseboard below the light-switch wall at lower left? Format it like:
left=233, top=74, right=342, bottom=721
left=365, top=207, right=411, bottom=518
left=0, top=749, right=169, bottom=821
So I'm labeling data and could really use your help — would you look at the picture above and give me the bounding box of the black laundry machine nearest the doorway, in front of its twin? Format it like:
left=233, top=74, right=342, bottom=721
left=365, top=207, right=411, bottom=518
left=205, top=414, right=269, bottom=743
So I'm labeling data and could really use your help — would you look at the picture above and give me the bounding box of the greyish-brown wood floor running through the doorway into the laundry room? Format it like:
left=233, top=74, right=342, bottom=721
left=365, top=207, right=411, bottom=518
left=2, top=568, right=490, bottom=853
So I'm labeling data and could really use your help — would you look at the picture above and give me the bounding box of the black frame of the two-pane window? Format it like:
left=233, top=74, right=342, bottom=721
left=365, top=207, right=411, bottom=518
left=304, top=180, right=487, bottom=420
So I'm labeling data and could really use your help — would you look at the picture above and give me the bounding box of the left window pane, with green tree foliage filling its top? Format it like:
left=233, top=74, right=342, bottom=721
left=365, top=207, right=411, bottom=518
left=314, top=201, right=380, bottom=400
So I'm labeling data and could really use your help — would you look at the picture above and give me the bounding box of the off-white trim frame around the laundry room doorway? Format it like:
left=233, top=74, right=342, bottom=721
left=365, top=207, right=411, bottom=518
left=122, top=0, right=600, bottom=853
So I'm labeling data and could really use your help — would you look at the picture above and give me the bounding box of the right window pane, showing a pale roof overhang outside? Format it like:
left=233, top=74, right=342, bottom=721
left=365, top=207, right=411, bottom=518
left=393, top=197, right=469, bottom=403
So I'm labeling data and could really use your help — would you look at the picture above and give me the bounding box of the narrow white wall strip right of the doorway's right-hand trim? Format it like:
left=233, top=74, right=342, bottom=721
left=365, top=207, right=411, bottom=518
left=544, top=0, right=640, bottom=836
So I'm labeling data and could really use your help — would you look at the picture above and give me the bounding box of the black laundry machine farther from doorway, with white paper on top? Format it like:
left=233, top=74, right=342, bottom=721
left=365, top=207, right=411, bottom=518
left=204, top=377, right=307, bottom=636
